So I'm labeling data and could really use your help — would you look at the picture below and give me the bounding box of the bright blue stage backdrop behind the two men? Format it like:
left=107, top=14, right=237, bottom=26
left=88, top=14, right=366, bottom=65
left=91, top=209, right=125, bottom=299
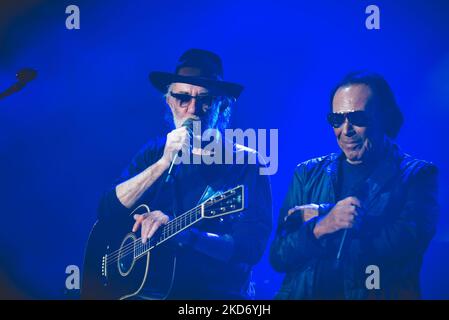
left=0, top=0, right=449, bottom=299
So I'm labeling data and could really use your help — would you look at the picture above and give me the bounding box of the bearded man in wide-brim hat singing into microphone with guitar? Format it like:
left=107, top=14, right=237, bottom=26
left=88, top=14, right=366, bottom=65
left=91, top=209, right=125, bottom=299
left=99, top=49, right=272, bottom=299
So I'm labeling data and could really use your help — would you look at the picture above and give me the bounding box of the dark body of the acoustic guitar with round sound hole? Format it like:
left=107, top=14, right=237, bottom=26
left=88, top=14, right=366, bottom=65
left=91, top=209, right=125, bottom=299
left=81, top=208, right=176, bottom=300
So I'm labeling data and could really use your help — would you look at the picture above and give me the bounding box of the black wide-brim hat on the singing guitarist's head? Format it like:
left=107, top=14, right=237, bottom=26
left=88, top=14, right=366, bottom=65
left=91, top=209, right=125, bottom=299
left=150, top=49, right=243, bottom=99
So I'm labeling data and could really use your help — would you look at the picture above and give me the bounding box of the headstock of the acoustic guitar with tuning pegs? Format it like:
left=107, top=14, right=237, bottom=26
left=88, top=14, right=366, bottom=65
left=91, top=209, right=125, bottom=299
left=201, top=185, right=245, bottom=218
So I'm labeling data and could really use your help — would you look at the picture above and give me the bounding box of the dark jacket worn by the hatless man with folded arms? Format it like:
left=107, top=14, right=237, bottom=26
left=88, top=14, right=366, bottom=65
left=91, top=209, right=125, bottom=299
left=270, top=142, right=438, bottom=299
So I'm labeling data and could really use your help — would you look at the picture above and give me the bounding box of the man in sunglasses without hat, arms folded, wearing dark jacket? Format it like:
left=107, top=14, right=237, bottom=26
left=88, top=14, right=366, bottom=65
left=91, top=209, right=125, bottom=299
left=270, top=72, right=438, bottom=299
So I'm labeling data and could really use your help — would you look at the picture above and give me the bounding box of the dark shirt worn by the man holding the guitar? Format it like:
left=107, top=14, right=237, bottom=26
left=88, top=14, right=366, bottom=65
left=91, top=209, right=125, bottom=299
left=99, top=139, right=272, bottom=299
